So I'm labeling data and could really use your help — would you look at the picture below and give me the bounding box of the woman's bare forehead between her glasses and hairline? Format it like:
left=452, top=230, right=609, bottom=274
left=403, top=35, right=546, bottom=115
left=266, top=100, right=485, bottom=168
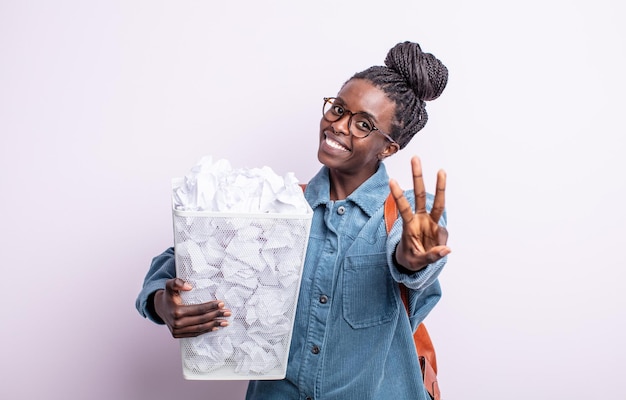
left=337, top=79, right=396, bottom=124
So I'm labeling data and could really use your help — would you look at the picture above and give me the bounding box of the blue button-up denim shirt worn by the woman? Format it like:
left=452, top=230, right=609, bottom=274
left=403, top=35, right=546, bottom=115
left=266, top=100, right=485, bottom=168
left=137, top=164, right=446, bottom=400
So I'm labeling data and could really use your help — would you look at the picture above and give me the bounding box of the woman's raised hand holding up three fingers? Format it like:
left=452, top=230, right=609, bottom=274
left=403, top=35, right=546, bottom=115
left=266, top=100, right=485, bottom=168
left=389, top=156, right=452, bottom=271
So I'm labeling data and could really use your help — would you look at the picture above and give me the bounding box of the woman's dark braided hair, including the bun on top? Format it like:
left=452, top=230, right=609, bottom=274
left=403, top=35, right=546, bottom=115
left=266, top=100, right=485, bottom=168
left=350, top=41, right=448, bottom=149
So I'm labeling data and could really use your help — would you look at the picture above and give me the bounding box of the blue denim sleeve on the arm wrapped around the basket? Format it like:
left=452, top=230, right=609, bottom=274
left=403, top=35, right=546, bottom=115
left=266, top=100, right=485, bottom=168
left=135, top=247, right=176, bottom=324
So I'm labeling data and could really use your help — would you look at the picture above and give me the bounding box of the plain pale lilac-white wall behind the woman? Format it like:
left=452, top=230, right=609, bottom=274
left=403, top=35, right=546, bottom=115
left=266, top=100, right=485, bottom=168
left=0, top=0, right=626, bottom=400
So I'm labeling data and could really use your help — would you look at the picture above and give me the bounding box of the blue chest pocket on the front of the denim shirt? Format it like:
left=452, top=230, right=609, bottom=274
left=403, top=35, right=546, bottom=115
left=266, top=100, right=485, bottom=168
left=342, top=252, right=398, bottom=329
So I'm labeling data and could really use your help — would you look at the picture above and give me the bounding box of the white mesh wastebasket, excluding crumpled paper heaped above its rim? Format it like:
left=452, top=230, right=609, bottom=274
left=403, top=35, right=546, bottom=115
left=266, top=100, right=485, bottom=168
left=173, top=203, right=313, bottom=380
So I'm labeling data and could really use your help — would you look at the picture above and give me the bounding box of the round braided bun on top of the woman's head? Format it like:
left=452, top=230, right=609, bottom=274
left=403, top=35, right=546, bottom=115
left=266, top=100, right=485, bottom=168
left=385, top=41, right=448, bottom=101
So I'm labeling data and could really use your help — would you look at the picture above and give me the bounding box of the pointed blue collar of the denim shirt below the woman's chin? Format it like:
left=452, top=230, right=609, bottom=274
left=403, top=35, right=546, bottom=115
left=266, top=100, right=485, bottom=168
left=305, top=163, right=389, bottom=217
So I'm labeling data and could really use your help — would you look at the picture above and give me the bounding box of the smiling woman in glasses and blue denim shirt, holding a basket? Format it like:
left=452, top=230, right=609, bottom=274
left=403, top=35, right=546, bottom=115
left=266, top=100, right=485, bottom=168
left=137, top=42, right=451, bottom=400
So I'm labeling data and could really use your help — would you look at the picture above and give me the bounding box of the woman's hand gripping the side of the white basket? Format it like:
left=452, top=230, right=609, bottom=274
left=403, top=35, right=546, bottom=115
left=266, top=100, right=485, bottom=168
left=154, top=278, right=232, bottom=338
